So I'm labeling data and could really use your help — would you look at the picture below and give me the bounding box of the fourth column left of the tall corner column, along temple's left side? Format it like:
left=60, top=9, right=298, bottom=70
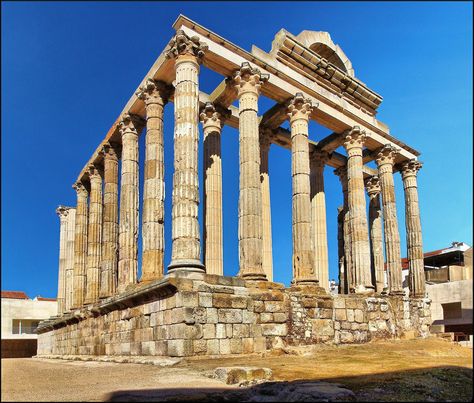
left=85, top=165, right=102, bottom=304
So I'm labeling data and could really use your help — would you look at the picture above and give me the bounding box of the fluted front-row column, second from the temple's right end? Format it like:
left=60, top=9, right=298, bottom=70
left=375, top=144, right=404, bottom=295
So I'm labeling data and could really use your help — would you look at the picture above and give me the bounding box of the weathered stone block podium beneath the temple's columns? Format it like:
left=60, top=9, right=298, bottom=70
left=38, top=274, right=431, bottom=357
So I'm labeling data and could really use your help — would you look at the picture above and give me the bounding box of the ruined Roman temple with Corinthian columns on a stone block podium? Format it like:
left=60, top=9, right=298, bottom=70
left=38, top=16, right=431, bottom=357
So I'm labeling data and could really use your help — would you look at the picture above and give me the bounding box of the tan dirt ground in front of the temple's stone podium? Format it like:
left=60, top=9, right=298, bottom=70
left=2, top=339, right=472, bottom=401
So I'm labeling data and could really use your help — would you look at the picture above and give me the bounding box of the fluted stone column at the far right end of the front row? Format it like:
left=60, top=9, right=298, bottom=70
left=401, top=160, right=425, bottom=298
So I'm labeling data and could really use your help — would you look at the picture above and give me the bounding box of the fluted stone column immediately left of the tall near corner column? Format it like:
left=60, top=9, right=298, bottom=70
left=137, top=79, right=170, bottom=281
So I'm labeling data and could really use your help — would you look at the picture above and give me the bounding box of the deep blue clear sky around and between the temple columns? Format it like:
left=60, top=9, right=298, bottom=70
left=1, top=1, right=472, bottom=297
